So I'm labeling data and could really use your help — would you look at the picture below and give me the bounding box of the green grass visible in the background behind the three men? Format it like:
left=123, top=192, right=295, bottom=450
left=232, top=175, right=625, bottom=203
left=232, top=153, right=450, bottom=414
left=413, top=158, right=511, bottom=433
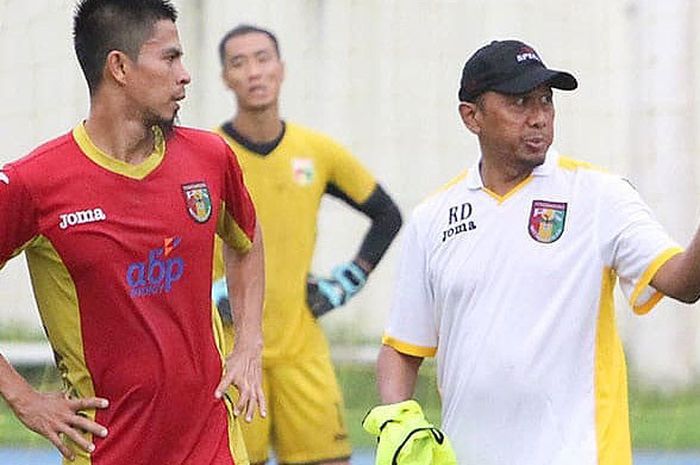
left=5, top=361, right=700, bottom=451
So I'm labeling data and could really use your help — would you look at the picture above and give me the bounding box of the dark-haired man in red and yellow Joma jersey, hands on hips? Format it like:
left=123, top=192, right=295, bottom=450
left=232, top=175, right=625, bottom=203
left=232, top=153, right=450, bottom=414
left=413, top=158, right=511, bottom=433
left=0, top=0, right=265, bottom=465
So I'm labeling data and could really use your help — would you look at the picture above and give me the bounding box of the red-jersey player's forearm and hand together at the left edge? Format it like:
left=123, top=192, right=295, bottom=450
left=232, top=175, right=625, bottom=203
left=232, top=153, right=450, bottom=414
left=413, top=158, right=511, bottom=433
left=0, top=355, right=109, bottom=460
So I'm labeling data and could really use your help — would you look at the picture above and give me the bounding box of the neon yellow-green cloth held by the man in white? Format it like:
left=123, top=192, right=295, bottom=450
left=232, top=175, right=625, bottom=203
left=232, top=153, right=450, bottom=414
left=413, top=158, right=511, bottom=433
left=362, top=400, right=457, bottom=465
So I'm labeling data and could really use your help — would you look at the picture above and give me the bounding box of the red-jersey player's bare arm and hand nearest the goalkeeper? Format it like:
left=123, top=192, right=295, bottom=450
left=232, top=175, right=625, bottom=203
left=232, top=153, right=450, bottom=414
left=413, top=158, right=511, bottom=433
left=216, top=223, right=267, bottom=421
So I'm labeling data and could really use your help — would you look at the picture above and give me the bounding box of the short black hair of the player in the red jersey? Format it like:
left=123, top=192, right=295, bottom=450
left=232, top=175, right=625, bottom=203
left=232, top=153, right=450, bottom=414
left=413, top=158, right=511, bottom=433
left=73, top=0, right=177, bottom=95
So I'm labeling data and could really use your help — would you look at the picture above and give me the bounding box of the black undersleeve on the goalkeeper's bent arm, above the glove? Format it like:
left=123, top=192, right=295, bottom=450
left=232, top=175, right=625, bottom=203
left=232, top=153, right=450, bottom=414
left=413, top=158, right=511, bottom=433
left=326, top=183, right=403, bottom=268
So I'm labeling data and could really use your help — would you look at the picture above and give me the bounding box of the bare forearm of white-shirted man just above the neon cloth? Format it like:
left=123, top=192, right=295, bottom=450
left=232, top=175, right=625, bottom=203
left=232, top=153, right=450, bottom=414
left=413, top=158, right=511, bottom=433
left=377, top=345, right=423, bottom=404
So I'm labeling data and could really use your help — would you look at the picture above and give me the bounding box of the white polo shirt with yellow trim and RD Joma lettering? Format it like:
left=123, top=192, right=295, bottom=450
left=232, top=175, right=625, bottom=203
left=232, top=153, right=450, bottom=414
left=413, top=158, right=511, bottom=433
left=383, top=151, right=681, bottom=465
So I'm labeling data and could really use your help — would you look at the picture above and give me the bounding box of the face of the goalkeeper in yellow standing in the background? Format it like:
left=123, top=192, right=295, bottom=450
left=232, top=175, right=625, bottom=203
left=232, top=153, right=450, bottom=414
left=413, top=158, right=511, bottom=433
left=223, top=32, right=284, bottom=111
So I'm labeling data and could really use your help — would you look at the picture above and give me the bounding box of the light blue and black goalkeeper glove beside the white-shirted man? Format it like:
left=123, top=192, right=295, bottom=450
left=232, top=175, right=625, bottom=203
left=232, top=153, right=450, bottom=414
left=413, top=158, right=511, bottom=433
left=306, top=262, right=367, bottom=318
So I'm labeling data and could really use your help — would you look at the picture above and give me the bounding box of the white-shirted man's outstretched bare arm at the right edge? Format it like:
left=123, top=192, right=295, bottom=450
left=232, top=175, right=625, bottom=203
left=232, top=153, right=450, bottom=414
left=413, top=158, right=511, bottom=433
left=651, top=229, right=700, bottom=303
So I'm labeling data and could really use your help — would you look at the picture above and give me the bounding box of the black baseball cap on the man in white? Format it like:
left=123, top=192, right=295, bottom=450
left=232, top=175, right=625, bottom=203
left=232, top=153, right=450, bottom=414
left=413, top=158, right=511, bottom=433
left=458, top=40, right=578, bottom=102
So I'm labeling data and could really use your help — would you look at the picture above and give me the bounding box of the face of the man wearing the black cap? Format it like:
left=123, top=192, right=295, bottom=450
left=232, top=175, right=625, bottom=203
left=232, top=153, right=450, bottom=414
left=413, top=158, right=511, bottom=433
left=459, top=85, right=554, bottom=169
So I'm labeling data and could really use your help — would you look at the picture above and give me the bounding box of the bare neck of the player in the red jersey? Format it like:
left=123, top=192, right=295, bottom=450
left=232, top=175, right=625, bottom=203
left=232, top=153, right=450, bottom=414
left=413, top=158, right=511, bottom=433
left=85, top=102, right=155, bottom=165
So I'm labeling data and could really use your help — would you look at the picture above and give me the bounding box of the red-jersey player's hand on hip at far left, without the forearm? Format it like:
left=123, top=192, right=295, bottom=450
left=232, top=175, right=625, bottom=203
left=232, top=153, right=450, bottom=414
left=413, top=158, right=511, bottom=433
left=10, top=390, right=109, bottom=460
